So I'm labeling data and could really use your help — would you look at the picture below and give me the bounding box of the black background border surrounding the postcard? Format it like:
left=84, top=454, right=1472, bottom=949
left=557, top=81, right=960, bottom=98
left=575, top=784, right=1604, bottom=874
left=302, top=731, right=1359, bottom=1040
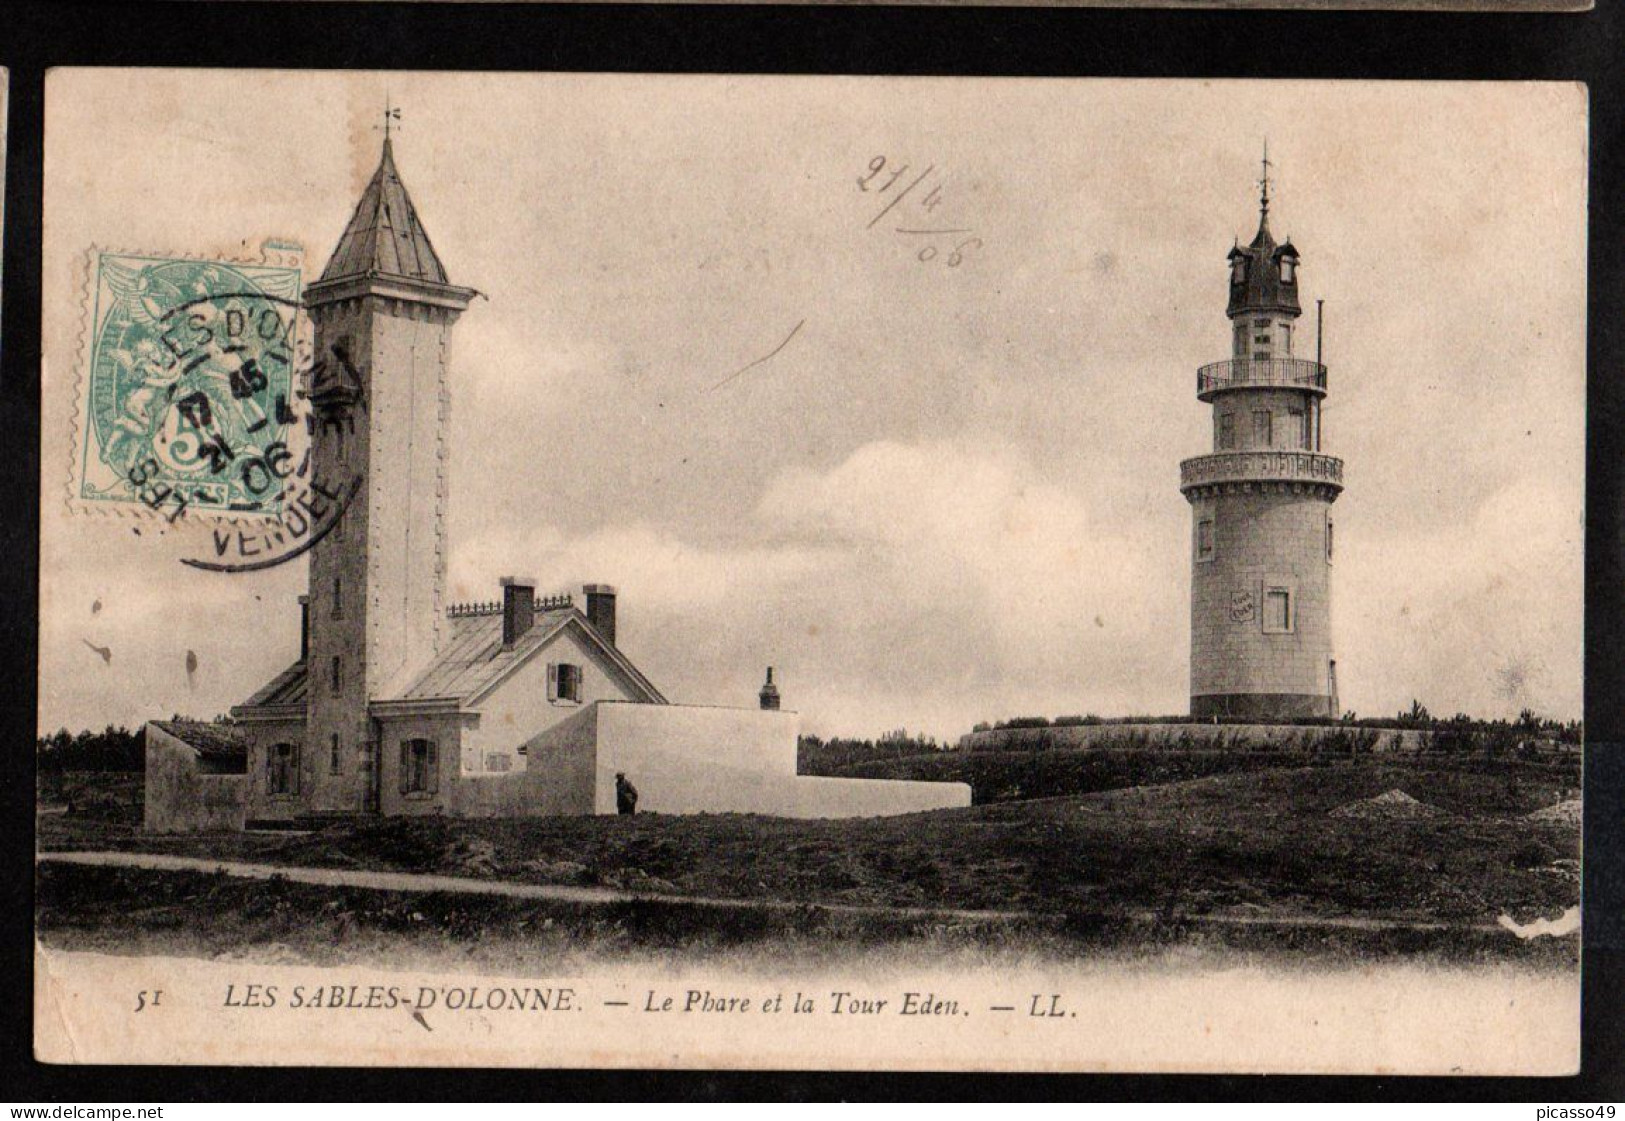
left=0, top=0, right=1625, bottom=1105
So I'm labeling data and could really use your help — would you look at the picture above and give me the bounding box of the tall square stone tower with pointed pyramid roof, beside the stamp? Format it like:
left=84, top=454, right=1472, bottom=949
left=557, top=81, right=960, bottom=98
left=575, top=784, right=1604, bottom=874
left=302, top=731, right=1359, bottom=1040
left=301, top=136, right=475, bottom=814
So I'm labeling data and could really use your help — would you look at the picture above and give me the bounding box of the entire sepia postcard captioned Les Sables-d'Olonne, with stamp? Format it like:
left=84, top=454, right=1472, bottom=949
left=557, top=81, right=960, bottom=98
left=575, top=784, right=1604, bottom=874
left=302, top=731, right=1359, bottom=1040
left=34, top=68, right=1588, bottom=1076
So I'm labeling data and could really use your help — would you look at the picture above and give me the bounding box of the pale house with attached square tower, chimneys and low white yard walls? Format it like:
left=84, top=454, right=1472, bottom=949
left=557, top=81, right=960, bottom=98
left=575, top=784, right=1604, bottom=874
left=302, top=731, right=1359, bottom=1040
left=148, top=140, right=970, bottom=829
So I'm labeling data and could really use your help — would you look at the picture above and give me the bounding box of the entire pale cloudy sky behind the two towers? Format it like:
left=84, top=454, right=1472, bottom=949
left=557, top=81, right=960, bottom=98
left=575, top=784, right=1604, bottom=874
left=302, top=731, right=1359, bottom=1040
left=41, top=71, right=1586, bottom=736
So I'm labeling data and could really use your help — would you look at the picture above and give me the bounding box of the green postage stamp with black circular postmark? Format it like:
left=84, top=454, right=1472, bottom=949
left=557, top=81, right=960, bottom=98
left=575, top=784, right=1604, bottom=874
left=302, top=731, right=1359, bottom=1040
left=70, top=242, right=307, bottom=522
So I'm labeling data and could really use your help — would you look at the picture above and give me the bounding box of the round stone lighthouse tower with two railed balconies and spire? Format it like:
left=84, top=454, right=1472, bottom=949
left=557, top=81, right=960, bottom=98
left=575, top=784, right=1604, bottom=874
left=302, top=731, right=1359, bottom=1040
left=1180, top=153, right=1342, bottom=718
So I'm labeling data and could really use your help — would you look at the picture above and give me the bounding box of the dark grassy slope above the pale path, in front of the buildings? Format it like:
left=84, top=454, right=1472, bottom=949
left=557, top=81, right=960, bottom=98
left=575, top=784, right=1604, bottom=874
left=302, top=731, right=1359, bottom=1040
left=41, top=759, right=1580, bottom=941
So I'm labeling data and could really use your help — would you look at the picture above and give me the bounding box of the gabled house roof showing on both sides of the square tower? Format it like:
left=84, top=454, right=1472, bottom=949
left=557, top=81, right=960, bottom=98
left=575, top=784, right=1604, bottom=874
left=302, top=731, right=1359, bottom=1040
left=239, top=608, right=666, bottom=708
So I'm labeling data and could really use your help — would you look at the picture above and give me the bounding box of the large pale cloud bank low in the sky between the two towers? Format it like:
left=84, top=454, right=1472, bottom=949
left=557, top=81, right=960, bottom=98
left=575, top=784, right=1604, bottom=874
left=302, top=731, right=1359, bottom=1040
left=453, top=439, right=1185, bottom=736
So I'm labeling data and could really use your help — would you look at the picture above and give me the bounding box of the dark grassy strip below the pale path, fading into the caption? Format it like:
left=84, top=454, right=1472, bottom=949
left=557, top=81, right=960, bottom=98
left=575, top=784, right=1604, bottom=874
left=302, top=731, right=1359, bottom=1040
left=39, top=864, right=1578, bottom=973
